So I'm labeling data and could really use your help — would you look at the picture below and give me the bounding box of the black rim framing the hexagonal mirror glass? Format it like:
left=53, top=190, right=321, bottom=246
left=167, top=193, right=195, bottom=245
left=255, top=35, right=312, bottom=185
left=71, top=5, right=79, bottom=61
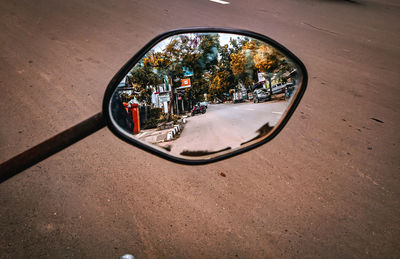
left=103, top=27, right=308, bottom=165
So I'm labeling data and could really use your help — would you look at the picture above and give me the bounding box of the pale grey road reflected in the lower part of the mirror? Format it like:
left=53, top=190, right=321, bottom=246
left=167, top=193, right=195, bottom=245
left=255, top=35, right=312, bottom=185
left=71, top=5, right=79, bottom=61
left=171, top=101, right=287, bottom=155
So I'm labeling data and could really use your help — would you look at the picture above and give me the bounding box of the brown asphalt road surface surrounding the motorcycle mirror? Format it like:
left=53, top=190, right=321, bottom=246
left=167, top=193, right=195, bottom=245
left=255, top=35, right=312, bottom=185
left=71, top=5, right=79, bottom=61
left=0, top=0, right=400, bottom=258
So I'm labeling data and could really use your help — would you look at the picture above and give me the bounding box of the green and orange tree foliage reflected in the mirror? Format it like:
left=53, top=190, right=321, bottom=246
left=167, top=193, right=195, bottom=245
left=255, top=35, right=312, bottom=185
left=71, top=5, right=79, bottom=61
left=129, top=34, right=291, bottom=116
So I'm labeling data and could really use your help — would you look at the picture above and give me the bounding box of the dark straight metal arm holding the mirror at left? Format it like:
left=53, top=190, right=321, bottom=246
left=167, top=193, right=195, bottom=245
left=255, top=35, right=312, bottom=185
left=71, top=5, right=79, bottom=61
left=0, top=112, right=106, bottom=183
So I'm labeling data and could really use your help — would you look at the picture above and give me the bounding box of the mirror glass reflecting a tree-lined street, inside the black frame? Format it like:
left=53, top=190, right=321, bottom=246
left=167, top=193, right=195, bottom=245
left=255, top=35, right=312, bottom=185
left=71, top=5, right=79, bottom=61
left=109, top=33, right=301, bottom=159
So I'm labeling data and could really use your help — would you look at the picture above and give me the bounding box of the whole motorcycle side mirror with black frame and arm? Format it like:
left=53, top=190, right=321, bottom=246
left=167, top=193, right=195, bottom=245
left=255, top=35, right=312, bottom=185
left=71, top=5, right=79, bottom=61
left=0, top=28, right=308, bottom=182
